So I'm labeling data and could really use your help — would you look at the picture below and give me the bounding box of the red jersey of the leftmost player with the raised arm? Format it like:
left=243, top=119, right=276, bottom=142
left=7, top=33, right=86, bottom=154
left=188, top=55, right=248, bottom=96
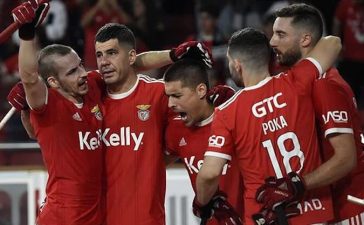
left=30, top=74, right=103, bottom=225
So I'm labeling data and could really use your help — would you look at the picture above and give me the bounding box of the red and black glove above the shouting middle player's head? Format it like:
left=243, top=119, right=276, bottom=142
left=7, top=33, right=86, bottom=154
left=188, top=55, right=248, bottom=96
left=169, top=41, right=212, bottom=68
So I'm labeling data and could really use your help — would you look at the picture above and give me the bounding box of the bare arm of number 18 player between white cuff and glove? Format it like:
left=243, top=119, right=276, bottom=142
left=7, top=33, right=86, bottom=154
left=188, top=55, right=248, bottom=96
left=196, top=156, right=226, bottom=205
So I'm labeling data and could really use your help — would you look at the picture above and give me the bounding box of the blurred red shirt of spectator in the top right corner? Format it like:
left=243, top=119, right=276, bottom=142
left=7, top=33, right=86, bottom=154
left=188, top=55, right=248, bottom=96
left=335, top=0, right=364, bottom=62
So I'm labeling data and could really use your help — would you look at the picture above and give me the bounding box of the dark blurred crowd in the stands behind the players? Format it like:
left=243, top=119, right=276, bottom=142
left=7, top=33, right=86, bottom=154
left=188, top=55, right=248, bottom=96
left=0, top=0, right=364, bottom=144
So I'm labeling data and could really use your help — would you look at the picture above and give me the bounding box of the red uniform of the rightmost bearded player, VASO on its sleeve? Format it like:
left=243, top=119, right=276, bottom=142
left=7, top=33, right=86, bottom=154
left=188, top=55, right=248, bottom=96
left=313, top=68, right=364, bottom=225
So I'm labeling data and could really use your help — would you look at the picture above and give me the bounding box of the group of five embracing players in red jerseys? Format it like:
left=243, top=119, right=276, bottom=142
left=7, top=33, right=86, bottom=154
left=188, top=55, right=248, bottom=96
left=4, top=0, right=364, bottom=225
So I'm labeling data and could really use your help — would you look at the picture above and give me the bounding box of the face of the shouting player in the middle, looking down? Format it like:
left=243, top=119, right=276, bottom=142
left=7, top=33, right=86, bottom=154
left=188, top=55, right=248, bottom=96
left=165, top=81, right=208, bottom=127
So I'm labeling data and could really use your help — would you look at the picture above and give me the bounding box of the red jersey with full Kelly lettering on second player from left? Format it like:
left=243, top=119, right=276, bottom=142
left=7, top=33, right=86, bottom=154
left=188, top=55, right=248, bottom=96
left=102, top=75, right=168, bottom=225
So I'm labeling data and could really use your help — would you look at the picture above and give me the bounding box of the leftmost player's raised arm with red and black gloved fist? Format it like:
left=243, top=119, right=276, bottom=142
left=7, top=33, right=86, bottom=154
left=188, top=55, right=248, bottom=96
left=12, top=0, right=49, bottom=108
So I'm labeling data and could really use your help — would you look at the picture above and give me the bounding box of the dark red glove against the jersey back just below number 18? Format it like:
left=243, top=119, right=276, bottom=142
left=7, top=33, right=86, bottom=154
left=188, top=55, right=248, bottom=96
left=255, top=172, right=306, bottom=210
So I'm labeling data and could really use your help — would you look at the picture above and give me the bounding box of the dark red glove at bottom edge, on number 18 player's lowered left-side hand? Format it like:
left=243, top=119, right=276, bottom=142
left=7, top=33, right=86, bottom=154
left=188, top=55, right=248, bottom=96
left=193, top=191, right=242, bottom=225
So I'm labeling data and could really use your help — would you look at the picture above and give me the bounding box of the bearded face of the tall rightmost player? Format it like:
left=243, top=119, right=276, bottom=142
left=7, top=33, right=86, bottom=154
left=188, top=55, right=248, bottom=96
left=270, top=17, right=302, bottom=67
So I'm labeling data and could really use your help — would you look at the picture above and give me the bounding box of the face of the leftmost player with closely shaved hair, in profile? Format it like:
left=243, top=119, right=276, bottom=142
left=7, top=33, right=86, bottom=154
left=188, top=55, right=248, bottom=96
left=48, top=51, right=88, bottom=99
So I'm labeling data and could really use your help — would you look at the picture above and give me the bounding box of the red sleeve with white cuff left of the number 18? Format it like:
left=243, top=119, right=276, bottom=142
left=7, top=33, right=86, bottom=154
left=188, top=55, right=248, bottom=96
left=205, top=109, right=234, bottom=160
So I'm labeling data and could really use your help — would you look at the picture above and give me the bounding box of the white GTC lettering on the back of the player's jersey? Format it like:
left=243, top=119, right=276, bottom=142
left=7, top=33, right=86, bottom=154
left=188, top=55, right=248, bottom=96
left=252, top=92, right=287, bottom=118
